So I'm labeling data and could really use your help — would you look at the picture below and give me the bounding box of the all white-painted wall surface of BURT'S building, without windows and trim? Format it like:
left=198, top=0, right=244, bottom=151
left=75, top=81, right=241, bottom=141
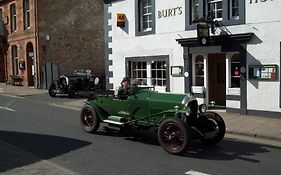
left=109, top=0, right=281, bottom=112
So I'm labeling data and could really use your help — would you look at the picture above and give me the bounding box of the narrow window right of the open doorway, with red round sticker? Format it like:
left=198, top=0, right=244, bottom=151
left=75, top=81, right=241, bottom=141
left=230, top=54, right=240, bottom=88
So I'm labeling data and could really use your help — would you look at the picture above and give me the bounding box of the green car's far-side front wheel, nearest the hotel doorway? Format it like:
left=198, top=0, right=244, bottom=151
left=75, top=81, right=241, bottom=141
left=201, top=112, right=225, bottom=145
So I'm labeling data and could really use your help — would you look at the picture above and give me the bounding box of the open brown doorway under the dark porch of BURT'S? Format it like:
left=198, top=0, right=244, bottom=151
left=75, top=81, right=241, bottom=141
left=208, top=53, right=226, bottom=106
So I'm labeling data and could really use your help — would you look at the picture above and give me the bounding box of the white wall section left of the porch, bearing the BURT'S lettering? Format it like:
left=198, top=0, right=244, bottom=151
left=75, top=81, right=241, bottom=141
left=109, top=0, right=185, bottom=93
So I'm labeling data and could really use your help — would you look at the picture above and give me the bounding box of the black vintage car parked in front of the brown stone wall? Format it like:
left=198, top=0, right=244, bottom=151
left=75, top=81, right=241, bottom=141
left=48, top=70, right=105, bottom=98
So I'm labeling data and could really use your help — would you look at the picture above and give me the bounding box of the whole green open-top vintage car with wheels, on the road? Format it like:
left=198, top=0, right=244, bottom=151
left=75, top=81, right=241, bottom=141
left=80, top=87, right=225, bottom=154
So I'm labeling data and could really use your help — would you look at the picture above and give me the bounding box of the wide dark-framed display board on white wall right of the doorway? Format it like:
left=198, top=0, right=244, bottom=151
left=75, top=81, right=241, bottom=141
left=249, top=65, right=278, bottom=81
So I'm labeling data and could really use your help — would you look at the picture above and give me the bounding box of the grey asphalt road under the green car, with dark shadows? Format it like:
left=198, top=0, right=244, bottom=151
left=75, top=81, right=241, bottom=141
left=0, top=94, right=281, bottom=175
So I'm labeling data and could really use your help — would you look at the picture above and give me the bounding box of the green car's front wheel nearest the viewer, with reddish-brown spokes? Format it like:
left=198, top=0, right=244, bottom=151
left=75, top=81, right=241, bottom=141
left=158, top=118, right=191, bottom=154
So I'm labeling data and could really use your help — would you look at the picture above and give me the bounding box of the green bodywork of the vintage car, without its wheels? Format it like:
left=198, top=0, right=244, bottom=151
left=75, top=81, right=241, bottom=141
left=87, top=88, right=186, bottom=126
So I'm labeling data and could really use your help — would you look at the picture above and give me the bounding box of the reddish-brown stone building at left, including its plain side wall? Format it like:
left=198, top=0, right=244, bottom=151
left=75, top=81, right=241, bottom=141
left=0, top=0, right=105, bottom=88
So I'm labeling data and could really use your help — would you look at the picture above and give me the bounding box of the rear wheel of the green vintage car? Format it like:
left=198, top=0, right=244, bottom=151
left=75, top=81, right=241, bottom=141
left=80, top=105, right=100, bottom=133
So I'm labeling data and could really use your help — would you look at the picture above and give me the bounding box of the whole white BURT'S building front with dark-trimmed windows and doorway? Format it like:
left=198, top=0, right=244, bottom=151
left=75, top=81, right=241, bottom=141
left=105, top=0, right=281, bottom=117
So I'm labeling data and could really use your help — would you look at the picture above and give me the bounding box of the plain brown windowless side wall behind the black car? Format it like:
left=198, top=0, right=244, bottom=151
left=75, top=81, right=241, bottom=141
left=38, top=0, right=105, bottom=75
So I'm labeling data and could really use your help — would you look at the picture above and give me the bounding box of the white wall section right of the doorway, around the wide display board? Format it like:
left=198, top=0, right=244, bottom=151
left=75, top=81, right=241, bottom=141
left=246, top=0, right=281, bottom=112
